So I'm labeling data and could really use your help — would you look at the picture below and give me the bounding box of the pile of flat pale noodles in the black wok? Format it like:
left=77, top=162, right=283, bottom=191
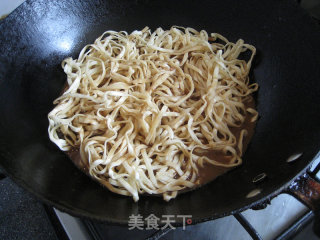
left=48, top=27, right=258, bottom=201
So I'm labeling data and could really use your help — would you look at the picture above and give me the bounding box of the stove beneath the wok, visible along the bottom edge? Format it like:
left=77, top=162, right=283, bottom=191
left=0, top=157, right=320, bottom=240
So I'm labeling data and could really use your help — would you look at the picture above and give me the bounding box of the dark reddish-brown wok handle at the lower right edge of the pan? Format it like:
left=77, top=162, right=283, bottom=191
left=288, top=173, right=320, bottom=237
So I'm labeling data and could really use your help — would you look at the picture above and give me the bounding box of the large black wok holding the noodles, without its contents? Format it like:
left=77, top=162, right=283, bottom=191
left=0, top=0, right=320, bottom=228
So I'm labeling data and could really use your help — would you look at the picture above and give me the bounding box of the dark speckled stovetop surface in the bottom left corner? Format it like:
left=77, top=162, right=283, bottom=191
left=0, top=171, right=58, bottom=240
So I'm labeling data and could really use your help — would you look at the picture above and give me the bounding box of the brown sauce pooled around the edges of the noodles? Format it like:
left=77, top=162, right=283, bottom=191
left=66, top=98, right=256, bottom=192
